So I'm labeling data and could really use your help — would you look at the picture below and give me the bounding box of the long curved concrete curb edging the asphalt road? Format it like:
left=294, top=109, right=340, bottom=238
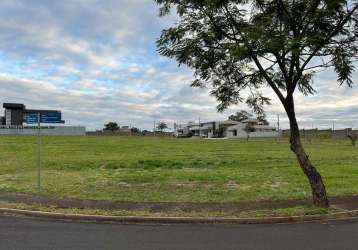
left=0, top=208, right=358, bottom=224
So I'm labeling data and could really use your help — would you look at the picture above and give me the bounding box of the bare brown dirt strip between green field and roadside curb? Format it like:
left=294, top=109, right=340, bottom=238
left=0, top=192, right=358, bottom=212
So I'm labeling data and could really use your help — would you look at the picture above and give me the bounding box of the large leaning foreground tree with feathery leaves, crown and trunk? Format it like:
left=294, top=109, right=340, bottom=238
left=155, top=0, right=358, bottom=207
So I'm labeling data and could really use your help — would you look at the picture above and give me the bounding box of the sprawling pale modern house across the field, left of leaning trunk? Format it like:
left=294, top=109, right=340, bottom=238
left=174, top=119, right=281, bottom=138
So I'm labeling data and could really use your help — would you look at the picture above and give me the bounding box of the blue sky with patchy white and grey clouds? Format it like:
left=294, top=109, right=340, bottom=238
left=0, top=0, right=358, bottom=130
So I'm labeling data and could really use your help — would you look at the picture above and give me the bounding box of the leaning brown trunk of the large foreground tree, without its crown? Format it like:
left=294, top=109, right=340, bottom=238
left=284, top=96, right=329, bottom=207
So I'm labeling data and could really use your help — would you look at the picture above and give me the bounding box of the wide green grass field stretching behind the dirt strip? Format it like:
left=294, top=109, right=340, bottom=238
left=0, top=136, right=358, bottom=202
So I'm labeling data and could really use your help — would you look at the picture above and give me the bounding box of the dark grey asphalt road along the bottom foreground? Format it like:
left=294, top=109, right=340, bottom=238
left=0, top=216, right=358, bottom=250
